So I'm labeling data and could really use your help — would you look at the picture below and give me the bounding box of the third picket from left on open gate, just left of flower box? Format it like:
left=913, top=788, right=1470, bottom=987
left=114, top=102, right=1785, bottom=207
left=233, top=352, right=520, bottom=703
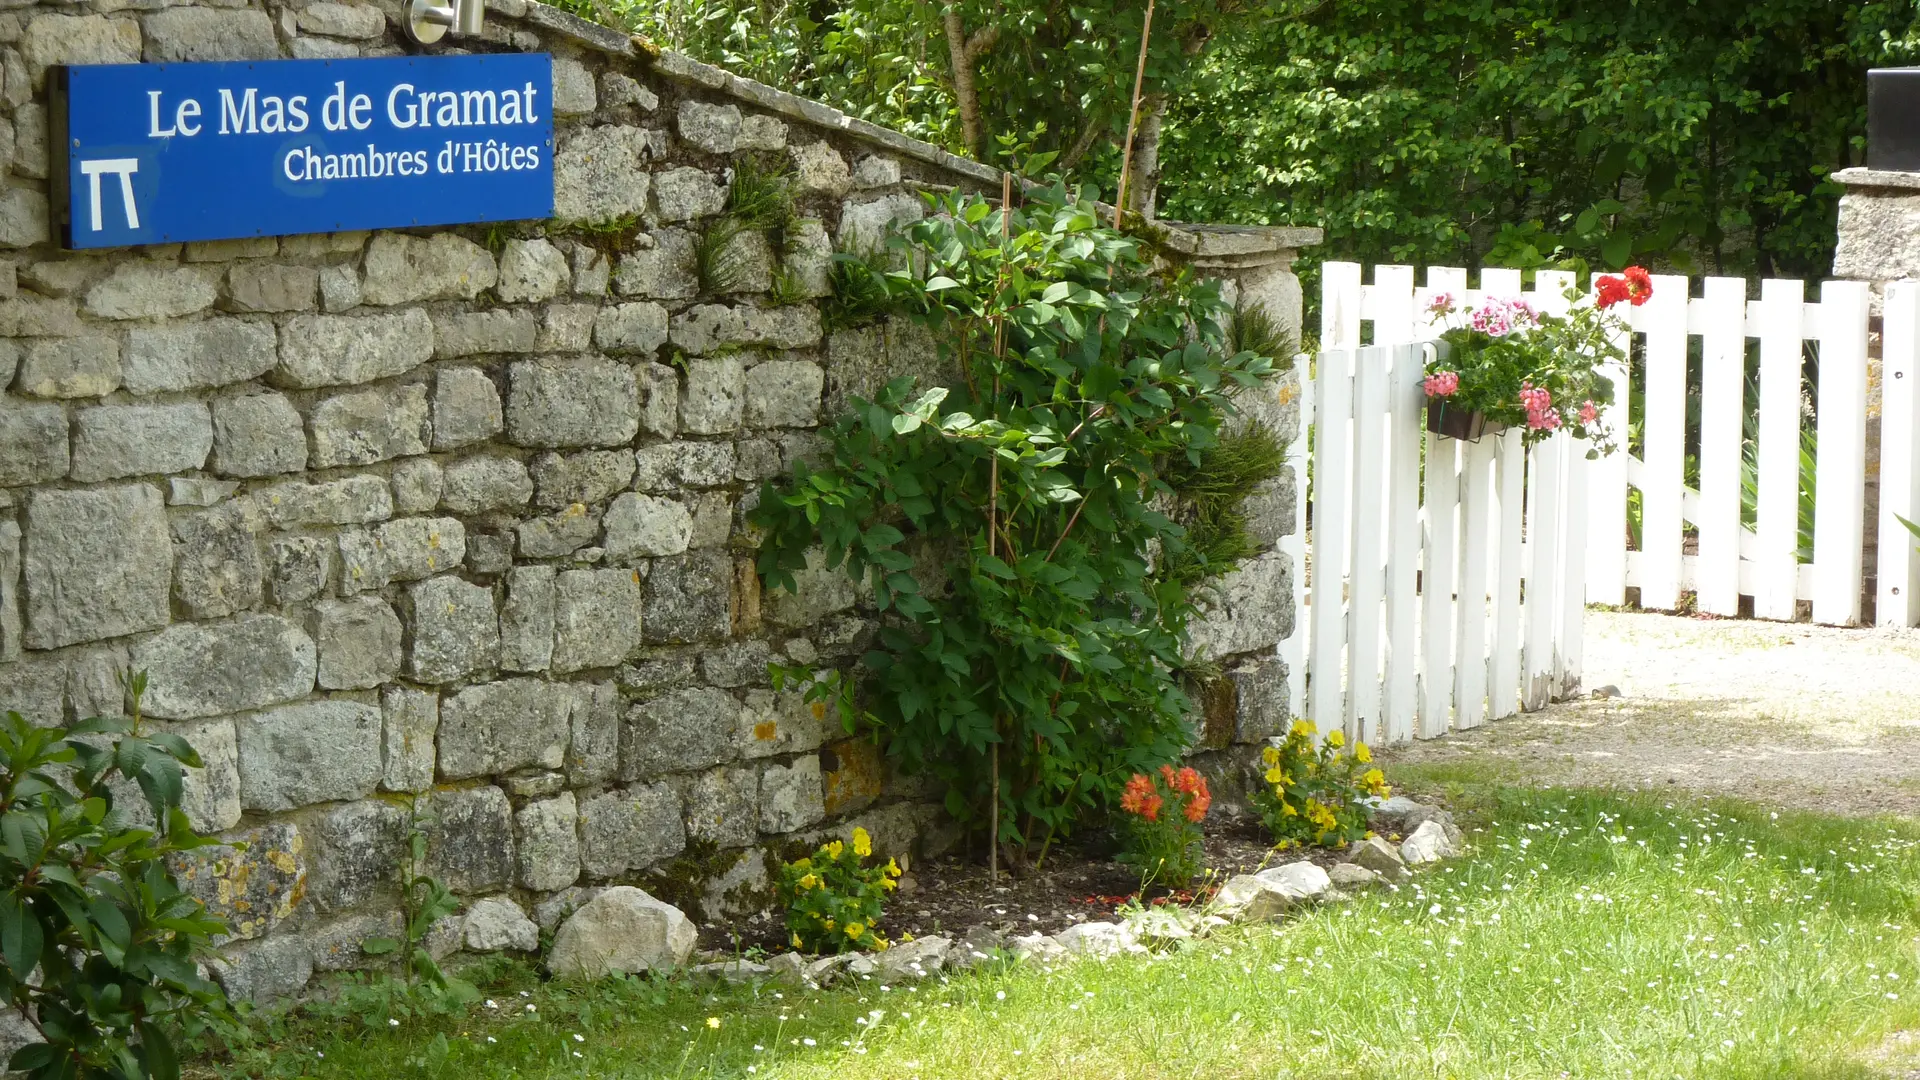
left=1382, top=344, right=1427, bottom=742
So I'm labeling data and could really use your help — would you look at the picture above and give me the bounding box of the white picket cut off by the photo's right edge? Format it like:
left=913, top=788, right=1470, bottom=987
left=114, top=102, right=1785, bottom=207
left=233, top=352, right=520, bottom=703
left=1874, top=281, right=1920, bottom=626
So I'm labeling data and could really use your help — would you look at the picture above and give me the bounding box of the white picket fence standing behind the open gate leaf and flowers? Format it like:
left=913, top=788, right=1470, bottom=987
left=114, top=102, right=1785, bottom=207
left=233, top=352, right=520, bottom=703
left=1321, top=263, right=1920, bottom=626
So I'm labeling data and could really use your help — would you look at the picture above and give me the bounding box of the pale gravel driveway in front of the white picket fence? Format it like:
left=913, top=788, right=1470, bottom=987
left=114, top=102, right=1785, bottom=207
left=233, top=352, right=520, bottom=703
left=1384, top=611, right=1920, bottom=815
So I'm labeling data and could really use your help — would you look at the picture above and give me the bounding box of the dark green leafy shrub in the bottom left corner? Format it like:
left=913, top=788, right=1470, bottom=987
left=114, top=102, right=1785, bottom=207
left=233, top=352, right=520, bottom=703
left=0, top=675, right=227, bottom=1080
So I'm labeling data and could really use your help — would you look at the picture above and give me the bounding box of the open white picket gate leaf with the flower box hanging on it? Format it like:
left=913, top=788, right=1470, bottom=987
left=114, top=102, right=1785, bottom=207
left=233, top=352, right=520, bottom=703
left=1288, top=263, right=1590, bottom=742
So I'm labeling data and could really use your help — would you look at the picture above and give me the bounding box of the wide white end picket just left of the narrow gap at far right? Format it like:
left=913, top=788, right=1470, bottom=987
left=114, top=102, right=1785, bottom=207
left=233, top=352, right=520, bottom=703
left=1812, top=281, right=1868, bottom=626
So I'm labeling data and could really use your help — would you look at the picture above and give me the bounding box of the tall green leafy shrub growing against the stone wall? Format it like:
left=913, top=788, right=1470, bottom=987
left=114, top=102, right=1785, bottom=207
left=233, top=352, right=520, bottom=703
left=753, top=186, right=1277, bottom=857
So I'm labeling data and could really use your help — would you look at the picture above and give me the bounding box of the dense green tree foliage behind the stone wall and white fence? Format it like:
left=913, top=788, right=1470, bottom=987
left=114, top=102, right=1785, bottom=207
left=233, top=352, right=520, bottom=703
left=587, top=0, right=1920, bottom=277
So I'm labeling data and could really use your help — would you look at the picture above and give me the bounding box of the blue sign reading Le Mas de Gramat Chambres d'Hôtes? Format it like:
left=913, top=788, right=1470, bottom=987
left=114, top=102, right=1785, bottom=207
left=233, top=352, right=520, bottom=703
left=52, top=54, right=553, bottom=248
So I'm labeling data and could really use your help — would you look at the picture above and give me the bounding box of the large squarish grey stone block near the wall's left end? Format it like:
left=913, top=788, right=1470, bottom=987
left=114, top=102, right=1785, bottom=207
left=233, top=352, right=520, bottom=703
left=21, top=484, right=173, bottom=650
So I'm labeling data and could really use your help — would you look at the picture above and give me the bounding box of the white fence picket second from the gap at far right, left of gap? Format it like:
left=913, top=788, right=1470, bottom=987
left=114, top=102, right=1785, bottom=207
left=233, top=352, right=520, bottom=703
left=1753, top=279, right=1807, bottom=619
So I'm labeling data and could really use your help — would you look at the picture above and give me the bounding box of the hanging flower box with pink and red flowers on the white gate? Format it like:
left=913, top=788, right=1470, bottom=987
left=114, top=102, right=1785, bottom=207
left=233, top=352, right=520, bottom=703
left=1423, top=267, right=1653, bottom=455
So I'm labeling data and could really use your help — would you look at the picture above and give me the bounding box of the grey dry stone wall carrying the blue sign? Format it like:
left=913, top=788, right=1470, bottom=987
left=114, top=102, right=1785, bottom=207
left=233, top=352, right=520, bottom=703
left=0, top=0, right=1302, bottom=995
